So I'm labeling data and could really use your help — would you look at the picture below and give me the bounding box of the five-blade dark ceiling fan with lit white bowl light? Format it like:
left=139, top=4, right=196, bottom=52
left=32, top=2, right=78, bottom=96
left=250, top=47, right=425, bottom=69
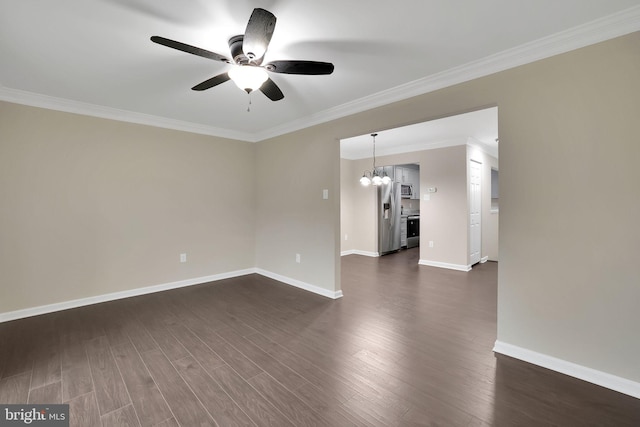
left=151, top=8, right=333, bottom=101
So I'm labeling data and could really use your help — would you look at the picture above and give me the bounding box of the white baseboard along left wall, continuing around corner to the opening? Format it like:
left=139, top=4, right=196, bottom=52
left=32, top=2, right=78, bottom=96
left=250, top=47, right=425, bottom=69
left=0, top=268, right=342, bottom=323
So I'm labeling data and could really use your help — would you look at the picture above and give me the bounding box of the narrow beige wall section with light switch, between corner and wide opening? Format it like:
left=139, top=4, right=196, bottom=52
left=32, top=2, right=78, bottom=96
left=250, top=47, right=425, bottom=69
left=255, top=131, right=340, bottom=292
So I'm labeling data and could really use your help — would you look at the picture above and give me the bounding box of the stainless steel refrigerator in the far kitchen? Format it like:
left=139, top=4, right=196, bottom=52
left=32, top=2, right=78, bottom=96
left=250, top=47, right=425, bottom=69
left=378, top=182, right=400, bottom=255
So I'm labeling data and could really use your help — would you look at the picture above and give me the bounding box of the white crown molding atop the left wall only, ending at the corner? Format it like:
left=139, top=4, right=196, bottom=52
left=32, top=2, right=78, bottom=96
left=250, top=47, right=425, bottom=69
left=0, top=86, right=256, bottom=142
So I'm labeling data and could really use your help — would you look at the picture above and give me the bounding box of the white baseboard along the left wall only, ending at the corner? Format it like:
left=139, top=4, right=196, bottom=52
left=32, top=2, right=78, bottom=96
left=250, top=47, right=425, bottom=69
left=0, top=268, right=256, bottom=323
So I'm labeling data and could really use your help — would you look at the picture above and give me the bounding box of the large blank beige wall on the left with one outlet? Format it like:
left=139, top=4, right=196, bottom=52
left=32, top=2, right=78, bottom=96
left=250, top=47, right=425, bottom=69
left=0, top=102, right=255, bottom=314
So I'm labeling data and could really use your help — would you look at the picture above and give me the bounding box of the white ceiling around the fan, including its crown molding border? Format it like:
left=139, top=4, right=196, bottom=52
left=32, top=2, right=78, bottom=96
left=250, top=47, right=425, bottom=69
left=0, top=0, right=640, bottom=141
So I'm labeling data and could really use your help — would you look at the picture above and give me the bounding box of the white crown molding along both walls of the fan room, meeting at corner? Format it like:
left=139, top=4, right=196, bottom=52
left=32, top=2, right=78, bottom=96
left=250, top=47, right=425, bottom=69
left=0, top=6, right=640, bottom=142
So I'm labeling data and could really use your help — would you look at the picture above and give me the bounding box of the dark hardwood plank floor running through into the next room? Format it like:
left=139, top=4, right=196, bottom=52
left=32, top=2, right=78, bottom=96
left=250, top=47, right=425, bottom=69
left=0, top=249, right=640, bottom=427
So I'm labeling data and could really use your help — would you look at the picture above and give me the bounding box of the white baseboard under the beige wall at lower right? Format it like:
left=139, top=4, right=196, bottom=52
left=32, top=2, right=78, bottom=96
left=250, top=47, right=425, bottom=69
left=493, top=340, right=640, bottom=399
